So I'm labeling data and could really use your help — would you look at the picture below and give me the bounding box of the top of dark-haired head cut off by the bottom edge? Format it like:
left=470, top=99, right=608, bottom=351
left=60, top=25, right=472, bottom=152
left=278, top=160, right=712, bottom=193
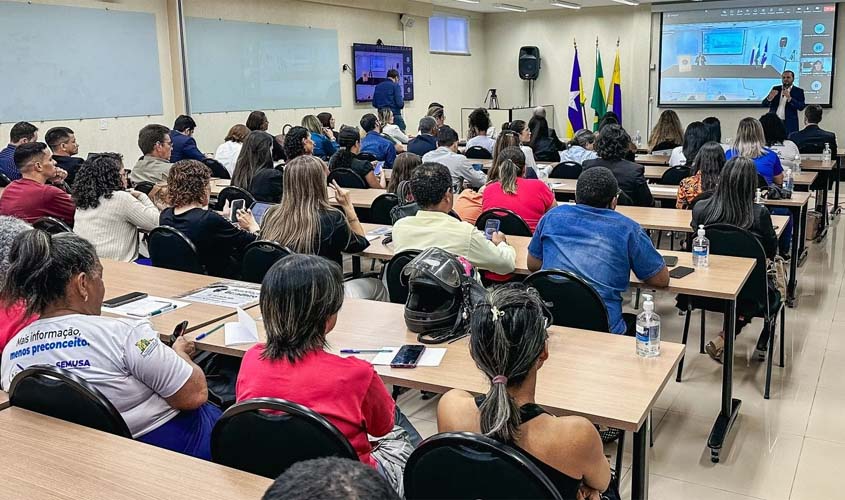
left=261, top=457, right=399, bottom=500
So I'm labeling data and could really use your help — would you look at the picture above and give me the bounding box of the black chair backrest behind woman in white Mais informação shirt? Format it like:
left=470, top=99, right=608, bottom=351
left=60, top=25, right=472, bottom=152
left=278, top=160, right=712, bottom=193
left=9, top=365, right=132, bottom=439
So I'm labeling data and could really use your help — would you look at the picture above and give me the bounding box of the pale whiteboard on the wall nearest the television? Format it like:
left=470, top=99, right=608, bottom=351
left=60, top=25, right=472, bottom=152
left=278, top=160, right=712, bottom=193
left=185, top=17, right=340, bottom=113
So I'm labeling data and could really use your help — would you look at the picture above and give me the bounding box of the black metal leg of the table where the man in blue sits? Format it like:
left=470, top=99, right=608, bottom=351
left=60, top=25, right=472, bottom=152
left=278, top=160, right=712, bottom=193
left=708, top=300, right=742, bottom=463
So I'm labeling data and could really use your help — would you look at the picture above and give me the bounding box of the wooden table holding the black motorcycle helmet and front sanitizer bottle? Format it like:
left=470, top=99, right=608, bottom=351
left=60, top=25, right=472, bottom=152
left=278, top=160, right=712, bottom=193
left=196, top=298, right=684, bottom=499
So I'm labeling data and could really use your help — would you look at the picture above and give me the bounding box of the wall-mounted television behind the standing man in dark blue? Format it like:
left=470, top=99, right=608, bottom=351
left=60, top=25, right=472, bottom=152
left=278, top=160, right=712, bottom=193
left=352, top=43, right=414, bottom=102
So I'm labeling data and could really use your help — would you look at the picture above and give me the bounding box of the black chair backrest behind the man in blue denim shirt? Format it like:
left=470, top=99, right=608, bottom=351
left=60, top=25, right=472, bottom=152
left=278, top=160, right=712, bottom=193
left=524, top=269, right=610, bottom=332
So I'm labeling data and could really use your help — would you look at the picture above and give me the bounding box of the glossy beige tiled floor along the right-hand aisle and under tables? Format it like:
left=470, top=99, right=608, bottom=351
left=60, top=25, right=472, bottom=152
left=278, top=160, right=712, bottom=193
left=399, top=193, right=845, bottom=500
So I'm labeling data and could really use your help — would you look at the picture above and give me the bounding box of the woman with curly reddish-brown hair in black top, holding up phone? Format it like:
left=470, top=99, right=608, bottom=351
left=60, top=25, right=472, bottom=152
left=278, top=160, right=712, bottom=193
left=159, top=160, right=264, bottom=278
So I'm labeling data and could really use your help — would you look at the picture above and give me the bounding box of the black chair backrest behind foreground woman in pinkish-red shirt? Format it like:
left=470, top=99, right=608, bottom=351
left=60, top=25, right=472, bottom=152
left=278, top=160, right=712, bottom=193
left=211, top=398, right=358, bottom=479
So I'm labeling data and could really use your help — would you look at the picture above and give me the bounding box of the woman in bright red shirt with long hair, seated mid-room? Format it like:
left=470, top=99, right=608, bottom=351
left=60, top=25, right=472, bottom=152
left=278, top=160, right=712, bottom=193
left=481, top=147, right=555, bottom=232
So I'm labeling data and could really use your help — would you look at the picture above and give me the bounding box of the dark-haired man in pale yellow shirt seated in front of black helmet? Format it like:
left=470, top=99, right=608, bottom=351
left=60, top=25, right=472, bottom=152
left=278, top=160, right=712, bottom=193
left=393, top=163, right=516, bottom=274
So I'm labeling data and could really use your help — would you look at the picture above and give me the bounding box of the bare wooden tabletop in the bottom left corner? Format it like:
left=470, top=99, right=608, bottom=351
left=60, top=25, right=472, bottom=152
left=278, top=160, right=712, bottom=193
left=0, top=408, right=272, bottom=500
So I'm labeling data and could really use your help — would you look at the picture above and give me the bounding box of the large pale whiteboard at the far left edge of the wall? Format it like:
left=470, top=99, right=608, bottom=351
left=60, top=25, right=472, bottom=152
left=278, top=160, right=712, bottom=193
left=0, top=1, right=162, bottom=123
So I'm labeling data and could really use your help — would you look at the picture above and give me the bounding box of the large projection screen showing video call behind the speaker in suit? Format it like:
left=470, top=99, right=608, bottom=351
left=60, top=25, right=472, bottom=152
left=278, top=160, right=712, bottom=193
left=658, top=4, right=836, bottom=106
